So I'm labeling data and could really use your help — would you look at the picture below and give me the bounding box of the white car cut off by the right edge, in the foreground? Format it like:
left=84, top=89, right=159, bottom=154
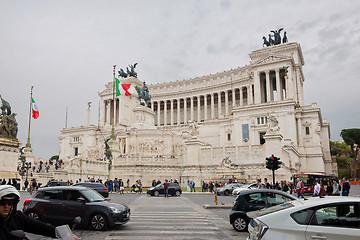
left=247, top=196, right=360, bottom=240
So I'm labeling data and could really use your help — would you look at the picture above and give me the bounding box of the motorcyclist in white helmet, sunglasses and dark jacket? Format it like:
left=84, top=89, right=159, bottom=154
left=0, top=185, right=79, bottom=240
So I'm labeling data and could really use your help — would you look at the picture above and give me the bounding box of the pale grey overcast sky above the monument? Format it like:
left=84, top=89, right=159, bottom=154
left=0, top=0, right=360, bottom=159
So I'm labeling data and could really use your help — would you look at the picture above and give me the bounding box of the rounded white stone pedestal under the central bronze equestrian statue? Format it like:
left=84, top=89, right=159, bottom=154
left=131, top=106, right=156, bottom=129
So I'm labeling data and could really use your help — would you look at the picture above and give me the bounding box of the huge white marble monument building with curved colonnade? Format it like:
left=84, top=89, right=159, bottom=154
left=59, top=43, right=337, bottom=186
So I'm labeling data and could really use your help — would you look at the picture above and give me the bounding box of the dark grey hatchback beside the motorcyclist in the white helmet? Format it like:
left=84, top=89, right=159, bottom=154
left=23, top=186, right=130, bottom=230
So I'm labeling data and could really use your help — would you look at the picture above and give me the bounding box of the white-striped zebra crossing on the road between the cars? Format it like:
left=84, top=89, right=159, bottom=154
left=106, top=196, right=245, bottom=240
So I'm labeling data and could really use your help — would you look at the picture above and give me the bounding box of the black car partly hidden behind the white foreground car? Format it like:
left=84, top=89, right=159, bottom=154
left=229, top=189, right=297, bottom=232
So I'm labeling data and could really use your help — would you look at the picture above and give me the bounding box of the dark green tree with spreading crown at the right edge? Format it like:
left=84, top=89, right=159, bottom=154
left=340, top=128, right=360, bottom=178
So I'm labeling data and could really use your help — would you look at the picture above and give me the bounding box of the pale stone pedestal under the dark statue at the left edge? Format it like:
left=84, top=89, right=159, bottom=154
left=0, top=137, right=21, bottom=179
